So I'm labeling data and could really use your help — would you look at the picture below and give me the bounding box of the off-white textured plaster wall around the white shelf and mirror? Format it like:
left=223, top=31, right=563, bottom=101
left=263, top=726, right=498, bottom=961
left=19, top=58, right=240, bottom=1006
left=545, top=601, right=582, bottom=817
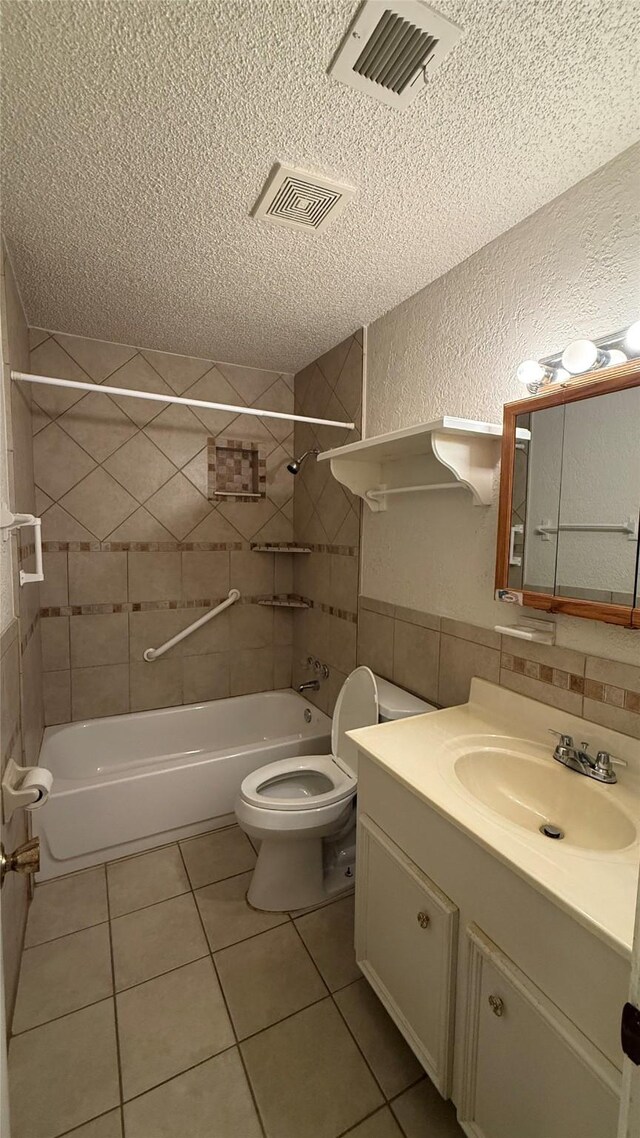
left=362, top=146, right=640, bottom=662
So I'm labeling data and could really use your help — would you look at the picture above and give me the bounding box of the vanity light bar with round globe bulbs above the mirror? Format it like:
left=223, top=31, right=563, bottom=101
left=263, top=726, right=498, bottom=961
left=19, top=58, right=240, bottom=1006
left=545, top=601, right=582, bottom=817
left=516, top=320, right=640, bottom=395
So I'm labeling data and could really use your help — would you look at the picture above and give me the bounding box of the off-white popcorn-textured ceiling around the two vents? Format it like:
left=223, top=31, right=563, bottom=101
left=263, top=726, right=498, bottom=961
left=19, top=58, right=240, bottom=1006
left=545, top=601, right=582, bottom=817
left=2, top=0, right=640, bottom=370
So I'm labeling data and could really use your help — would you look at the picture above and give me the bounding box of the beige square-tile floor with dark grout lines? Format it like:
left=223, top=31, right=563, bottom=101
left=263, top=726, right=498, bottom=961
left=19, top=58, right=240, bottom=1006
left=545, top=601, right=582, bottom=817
left=9, top=826, right=462, bottom=1138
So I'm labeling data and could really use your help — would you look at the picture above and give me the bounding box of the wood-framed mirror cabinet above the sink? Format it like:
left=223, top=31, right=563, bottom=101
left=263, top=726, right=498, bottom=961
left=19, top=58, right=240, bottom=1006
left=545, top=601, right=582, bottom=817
left=495, top=361, right=640, bottom=626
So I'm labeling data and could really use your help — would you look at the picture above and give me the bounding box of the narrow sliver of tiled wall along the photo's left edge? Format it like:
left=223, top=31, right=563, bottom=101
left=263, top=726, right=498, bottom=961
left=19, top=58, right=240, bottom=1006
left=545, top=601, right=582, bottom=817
left=0, top=242, right=42, bottom=1024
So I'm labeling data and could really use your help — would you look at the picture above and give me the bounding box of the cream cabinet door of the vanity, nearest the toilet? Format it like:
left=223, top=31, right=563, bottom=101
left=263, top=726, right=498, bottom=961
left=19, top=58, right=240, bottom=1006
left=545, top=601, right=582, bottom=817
left=355, top=815, right=458, bottom=1098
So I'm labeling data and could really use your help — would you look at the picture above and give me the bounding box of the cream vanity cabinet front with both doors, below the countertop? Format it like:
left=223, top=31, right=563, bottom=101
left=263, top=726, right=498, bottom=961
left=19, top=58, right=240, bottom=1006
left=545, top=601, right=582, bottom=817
left=355, top=752, right=629, bottom=1138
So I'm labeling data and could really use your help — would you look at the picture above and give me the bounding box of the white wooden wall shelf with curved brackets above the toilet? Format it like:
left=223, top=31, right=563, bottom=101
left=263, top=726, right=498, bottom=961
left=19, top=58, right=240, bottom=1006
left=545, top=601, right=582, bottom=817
left=318, top=415, right=514, bottom=513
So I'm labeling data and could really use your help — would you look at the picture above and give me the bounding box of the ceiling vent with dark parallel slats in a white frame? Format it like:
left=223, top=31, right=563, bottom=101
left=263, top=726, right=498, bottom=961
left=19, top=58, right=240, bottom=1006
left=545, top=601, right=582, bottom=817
left=329, top=0, right=462, bottom=109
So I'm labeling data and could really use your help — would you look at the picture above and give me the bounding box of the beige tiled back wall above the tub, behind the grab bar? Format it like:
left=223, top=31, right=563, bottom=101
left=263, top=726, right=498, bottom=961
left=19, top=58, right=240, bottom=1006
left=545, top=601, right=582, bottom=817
left=27, top=329, right=294, bottom=724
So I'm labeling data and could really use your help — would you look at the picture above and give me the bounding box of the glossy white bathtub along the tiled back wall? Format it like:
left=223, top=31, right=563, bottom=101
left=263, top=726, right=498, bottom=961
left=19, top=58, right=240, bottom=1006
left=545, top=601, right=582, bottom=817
left=31, top=691, right=331, bottom=881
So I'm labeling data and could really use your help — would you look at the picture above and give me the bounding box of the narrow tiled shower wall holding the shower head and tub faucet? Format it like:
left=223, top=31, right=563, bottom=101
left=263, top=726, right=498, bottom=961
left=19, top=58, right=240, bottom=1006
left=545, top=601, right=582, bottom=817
left=293, top=331, right=363, bottom=714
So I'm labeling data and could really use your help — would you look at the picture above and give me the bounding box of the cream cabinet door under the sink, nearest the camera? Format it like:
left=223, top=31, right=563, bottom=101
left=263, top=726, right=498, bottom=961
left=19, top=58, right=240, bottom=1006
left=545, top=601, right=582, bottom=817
left=458, top=925, right=620, bottom=1138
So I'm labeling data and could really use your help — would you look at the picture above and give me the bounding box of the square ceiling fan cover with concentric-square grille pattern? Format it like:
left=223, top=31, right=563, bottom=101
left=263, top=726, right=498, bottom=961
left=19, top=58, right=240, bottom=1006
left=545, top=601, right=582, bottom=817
left=253, top=163, right=355, bottom=233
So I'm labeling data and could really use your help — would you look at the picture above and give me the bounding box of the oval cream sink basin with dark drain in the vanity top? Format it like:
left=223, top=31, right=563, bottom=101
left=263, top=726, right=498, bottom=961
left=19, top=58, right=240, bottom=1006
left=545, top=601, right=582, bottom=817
left=454, top=749, right=638, bottom=850
